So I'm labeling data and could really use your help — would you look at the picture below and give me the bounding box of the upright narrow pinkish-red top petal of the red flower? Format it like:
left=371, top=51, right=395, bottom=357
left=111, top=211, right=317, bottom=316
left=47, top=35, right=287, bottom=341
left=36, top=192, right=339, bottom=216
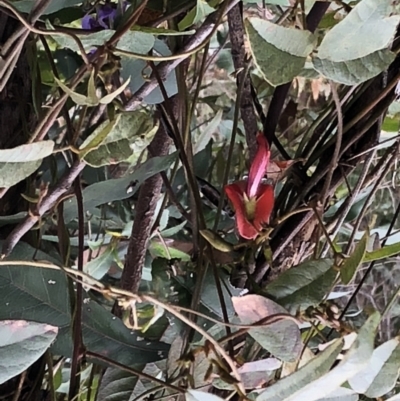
left=247, top=132, right=271, bottom=198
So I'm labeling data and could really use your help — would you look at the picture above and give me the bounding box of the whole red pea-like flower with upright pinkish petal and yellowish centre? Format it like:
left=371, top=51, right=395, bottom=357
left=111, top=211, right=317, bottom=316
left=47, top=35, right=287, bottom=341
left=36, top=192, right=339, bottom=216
left=225, top=132, right=274, bottom=239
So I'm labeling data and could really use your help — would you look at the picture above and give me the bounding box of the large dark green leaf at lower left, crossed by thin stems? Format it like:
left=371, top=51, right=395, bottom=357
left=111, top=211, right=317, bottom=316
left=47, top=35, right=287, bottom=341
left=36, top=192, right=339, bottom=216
left=0, top=242, right=169, bottom=366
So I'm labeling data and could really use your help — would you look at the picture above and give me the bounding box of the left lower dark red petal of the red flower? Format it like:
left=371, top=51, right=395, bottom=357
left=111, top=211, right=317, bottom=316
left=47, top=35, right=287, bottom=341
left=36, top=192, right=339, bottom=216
left=224, top=182, right=258, bottom=239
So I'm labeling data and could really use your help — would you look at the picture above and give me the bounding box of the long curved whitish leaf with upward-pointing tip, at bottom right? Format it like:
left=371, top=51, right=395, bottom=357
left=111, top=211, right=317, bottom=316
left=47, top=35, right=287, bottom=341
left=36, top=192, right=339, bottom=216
left=268, top=312, right=381, bottom=401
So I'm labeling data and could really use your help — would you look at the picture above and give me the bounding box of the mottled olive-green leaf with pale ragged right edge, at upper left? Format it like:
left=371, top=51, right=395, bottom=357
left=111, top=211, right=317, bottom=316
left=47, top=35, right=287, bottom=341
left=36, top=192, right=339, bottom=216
left=81, top=111, right=157, bottom=167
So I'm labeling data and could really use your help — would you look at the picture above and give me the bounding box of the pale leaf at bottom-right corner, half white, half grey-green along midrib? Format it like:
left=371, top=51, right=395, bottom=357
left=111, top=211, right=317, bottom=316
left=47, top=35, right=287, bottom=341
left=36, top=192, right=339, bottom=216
left=349, top=338, right=400, bottom=398
